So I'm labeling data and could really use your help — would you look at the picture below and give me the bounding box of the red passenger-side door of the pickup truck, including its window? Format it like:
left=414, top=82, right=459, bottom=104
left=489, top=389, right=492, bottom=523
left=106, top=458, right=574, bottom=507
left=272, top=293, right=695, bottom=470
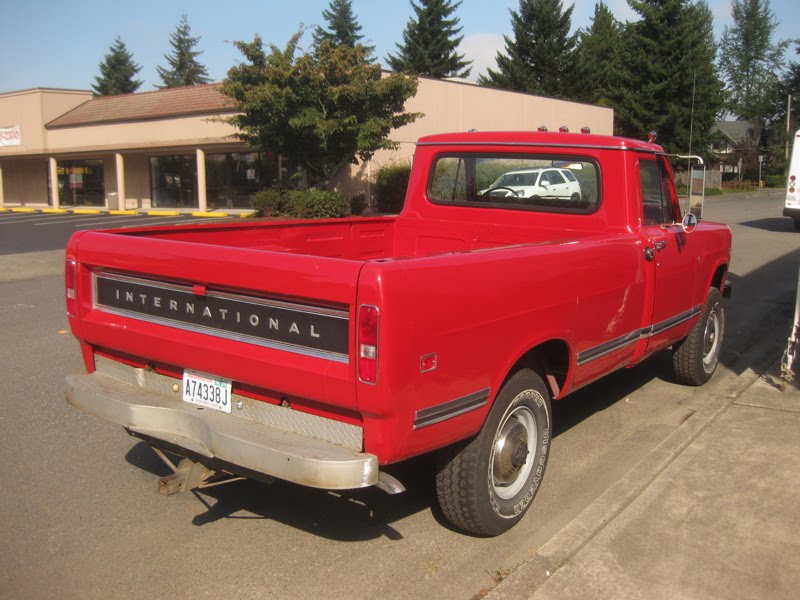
left=639, top=156, right=700, bottom=353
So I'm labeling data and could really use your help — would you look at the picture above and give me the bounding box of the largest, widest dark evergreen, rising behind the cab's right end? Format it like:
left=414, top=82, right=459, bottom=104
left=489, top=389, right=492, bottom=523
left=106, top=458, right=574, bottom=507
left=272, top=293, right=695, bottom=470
left=612, top=0, right=722, bottom=154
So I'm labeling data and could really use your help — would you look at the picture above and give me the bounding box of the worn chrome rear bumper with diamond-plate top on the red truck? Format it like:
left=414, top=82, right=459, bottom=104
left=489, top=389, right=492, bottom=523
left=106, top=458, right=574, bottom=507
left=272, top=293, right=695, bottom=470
left=66, top=359, right=379, bottom=489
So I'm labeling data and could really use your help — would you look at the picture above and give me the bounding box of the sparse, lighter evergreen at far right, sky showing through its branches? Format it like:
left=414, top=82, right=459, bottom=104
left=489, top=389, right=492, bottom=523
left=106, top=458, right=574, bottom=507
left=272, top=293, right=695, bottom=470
left=719, top=0, right=789, bottom=121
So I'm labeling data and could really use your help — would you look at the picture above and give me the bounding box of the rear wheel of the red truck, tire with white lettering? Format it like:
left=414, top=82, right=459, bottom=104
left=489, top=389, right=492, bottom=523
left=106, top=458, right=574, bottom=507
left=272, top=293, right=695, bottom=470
left=436, top=369, right=551, bottom=536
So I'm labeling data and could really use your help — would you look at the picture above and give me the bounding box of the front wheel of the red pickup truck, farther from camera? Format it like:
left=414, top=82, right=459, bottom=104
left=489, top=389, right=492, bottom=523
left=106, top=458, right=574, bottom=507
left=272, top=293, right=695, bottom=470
left=672, top=288, right=725, bottom=385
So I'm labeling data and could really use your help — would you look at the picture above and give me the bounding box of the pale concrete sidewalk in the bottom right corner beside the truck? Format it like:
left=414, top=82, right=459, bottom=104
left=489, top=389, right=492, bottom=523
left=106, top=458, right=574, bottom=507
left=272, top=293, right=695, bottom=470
left=490, top=363, right=800, bottom=600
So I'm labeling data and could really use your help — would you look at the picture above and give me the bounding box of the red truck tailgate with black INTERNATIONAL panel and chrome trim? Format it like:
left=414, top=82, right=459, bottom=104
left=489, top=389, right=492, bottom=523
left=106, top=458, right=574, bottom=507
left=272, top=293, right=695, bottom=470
left=67, top=231, right=363, bottom=411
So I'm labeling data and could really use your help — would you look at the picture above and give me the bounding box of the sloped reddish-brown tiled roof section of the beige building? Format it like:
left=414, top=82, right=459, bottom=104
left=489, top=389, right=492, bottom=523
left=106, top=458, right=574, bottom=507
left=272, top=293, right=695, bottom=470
left=47, top=83, right=235, bottom=129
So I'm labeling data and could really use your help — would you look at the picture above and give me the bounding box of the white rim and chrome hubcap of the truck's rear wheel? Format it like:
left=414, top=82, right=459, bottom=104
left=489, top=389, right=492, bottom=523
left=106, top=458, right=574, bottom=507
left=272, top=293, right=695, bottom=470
left=490, top=400, right=537, bottom=500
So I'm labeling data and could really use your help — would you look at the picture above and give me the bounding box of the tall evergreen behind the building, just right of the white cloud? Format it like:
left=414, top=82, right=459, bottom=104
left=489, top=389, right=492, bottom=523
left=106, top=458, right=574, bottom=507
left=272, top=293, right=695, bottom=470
left=479, top=0, right=576, bottom=98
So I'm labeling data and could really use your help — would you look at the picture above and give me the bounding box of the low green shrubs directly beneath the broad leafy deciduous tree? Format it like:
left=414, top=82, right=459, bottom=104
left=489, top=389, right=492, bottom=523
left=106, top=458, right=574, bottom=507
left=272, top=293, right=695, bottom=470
left=250, top=188, right=350, bottom=219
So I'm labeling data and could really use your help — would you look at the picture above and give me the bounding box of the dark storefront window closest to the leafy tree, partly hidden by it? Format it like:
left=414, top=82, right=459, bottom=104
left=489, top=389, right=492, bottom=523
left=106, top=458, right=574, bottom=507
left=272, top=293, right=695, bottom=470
left=206, top=152, right=278, bottom=210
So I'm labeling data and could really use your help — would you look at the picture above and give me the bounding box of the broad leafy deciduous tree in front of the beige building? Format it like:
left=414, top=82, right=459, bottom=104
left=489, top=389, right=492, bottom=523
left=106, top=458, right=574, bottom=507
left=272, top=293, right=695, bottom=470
left=221, top=31, right=419, bottom=189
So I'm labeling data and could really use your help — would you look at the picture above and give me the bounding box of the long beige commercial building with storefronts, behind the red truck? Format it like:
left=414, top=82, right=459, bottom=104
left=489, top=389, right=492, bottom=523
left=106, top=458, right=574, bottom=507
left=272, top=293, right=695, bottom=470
left=0, top=78, right=614, bottom=211
